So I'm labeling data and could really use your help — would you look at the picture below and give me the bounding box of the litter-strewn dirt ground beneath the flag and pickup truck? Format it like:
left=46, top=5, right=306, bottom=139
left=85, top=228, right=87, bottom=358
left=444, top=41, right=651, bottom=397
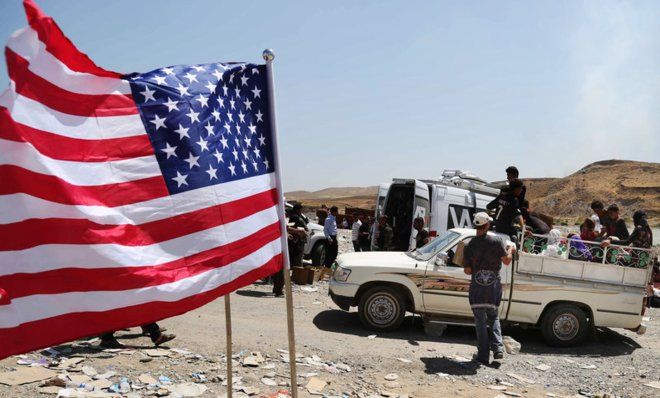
left=0, top=274, right=660, bottom=398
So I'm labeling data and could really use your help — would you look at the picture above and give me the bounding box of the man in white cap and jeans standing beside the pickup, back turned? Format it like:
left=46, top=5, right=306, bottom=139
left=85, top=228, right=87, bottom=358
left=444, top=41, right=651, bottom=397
left=463, top=212, right=515, bottom=365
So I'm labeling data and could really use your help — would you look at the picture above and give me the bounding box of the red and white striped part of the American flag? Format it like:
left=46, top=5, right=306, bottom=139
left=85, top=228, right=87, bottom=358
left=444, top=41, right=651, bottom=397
left=0, top=0, right=282, bottom=358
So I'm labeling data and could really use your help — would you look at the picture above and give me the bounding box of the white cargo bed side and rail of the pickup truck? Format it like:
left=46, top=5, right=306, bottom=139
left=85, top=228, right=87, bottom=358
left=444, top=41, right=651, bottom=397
left=516, top=234, right=653, bottom=287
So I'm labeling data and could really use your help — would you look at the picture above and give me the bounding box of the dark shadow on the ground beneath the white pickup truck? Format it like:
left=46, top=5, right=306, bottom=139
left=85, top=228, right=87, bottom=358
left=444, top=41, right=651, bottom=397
left=313, top=310, right=641, bottom=356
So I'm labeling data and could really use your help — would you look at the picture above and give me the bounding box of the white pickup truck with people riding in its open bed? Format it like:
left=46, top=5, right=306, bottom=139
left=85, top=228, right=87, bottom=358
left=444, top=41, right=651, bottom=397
left=329, top=228, right=653, bottom=346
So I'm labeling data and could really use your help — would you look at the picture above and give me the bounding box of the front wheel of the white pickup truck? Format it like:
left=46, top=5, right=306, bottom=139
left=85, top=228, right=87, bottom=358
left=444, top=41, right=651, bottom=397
left=358, top=286, right=406, bottom=332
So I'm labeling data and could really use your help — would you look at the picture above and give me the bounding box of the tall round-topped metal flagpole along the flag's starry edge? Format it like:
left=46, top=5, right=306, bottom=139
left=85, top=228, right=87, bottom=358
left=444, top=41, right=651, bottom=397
left=263, top=49, right=298, bottom=398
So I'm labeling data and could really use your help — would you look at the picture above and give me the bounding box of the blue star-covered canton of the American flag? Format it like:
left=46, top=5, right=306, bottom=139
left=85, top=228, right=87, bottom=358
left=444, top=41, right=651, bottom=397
left=130, top=63, right=274, bottom=194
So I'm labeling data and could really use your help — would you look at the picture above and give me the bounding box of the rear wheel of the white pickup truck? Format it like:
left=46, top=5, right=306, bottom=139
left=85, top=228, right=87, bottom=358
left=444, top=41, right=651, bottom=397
left=541, top=304, right=589, bottom=347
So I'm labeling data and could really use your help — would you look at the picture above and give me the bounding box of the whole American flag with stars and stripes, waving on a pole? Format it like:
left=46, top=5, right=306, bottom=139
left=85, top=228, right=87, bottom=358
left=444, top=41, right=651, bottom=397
left=0, top=0, right=282, bottom=358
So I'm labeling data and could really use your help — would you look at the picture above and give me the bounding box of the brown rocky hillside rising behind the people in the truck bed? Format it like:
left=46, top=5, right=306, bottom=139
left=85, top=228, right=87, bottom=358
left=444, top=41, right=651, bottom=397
left=525, top=160, right=660, bottom=223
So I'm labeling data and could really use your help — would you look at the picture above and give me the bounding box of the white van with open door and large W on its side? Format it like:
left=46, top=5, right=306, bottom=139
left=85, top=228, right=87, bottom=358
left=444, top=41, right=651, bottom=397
left=372, top=170, right=500, bottom=251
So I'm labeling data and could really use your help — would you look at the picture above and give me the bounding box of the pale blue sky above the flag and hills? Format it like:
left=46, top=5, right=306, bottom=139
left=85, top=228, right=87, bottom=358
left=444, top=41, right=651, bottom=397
left=0, top=0, right=660, bottom=190
